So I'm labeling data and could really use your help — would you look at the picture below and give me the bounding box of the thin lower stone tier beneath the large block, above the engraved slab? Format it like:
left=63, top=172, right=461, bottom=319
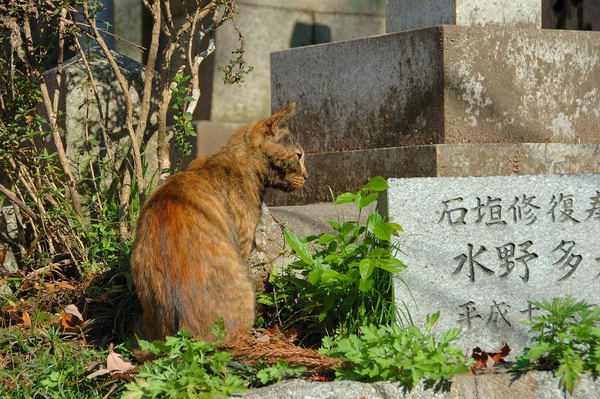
left=267, top=143, right=600, bottom=205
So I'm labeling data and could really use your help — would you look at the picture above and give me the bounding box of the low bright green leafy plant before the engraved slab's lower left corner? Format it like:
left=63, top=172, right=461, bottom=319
left=321, top=312, right=469, bottom=389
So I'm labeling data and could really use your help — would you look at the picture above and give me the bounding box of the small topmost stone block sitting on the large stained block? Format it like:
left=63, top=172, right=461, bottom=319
left=386, top=0, right=542, bottom=33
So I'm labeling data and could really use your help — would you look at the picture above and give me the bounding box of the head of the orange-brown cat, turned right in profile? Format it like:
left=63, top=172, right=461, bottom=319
left=260, top=103, right=308, bottom=191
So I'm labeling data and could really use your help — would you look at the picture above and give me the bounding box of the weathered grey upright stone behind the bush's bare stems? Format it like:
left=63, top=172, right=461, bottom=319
left=41, top=48, right=158, bottom=191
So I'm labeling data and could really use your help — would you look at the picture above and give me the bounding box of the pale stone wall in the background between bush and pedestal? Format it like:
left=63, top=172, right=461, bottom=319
left=210, top=0, right=385, bottom=122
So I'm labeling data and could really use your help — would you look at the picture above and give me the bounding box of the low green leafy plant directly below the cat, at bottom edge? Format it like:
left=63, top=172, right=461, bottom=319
left=123, top=320, right=246, bottom=398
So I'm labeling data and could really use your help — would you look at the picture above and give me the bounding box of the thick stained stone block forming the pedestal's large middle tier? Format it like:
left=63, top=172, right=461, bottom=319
left=271, top=26, right=600, bottom=153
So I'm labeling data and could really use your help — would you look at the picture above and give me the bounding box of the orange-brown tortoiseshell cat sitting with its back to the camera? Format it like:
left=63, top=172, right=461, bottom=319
left=131, top=103, right=308, bottom=340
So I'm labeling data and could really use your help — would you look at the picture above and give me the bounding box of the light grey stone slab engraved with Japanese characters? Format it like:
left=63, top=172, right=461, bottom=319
left=383, top=174, right=600, bottom=356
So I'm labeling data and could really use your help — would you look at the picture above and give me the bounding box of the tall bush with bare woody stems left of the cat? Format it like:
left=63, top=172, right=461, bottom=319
left=0, top=0, right=252, bottom=278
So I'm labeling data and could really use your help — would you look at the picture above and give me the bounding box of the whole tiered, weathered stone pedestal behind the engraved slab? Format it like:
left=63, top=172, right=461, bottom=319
left=270, top=0, right=600, bottom=204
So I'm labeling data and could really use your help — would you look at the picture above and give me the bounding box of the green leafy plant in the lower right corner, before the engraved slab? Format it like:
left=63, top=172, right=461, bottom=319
left=512, top=297, right=600, bottom=392
